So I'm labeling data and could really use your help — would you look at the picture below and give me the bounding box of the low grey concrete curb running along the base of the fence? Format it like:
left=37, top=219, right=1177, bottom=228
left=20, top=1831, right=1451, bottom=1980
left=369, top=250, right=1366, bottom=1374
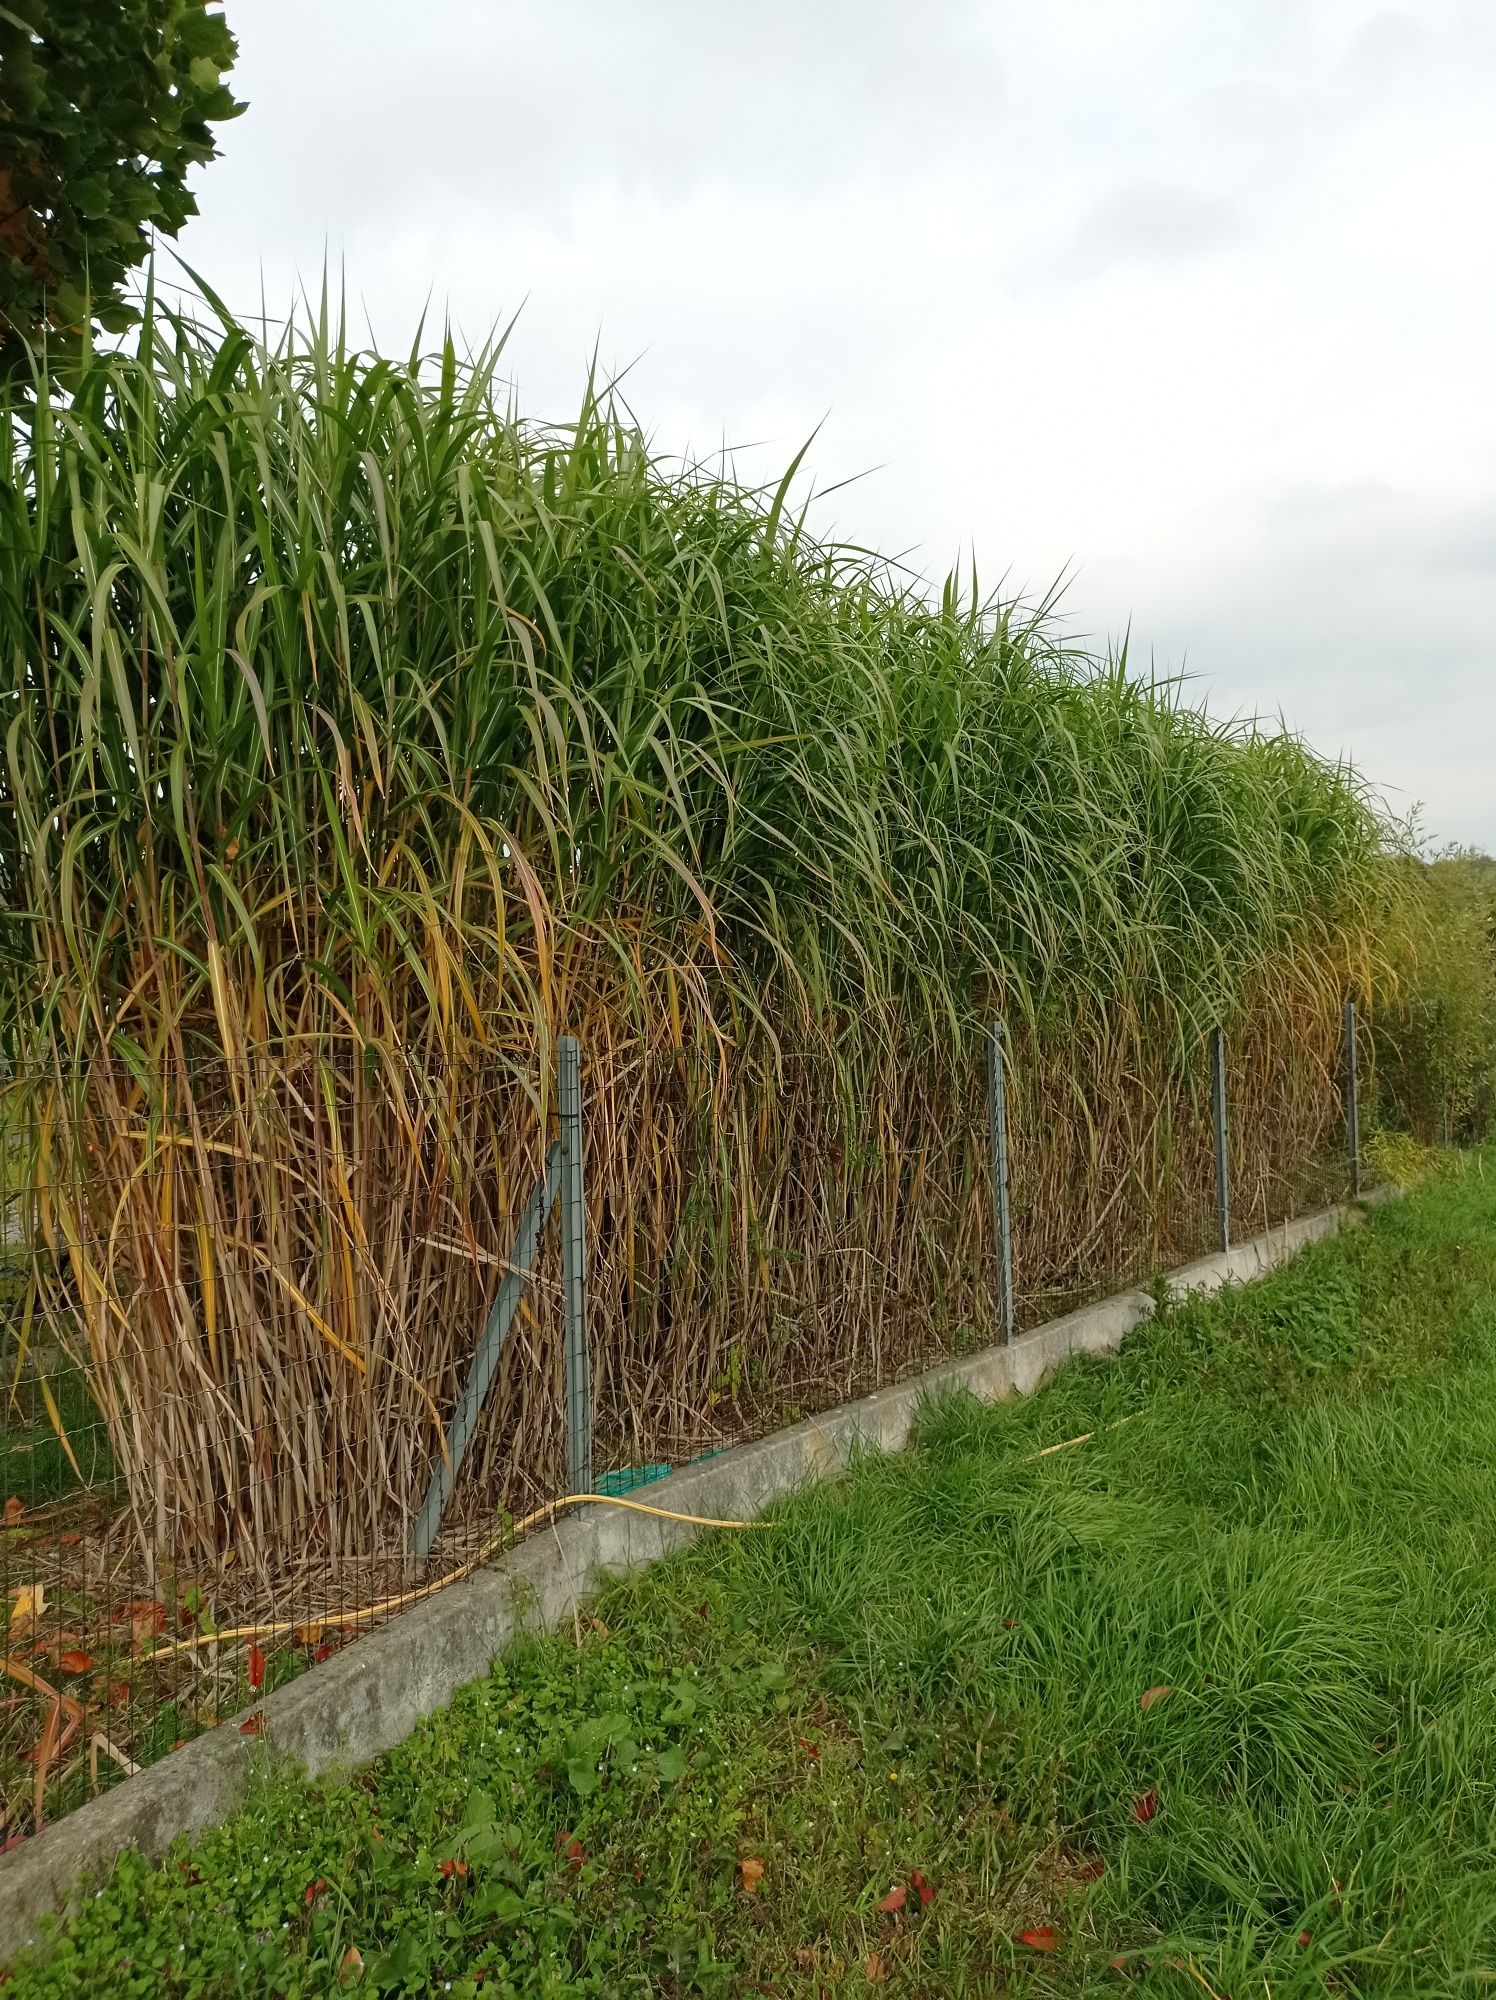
left=0, top=1190, right=1400, bottom=1964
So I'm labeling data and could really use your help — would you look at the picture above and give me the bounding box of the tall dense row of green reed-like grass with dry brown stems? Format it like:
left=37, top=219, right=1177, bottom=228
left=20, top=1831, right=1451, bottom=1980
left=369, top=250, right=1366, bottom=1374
left=0, top=300, right=1386, bottom=1566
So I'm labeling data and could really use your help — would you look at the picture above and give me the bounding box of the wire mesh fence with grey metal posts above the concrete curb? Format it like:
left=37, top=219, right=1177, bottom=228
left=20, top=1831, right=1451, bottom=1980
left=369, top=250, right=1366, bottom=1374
left=0, top=1008, right=1358, bottom=1840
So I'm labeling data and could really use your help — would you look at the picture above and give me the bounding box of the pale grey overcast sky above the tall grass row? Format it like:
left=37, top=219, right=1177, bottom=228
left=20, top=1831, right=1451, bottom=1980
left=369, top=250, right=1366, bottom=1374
left=180, top=0, right=1496, bottom=848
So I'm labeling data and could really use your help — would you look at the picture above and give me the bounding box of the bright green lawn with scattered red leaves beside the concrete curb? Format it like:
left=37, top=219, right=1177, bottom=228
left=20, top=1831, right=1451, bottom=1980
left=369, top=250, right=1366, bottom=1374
left=12, top=1160, right=1496, bottom=2000
